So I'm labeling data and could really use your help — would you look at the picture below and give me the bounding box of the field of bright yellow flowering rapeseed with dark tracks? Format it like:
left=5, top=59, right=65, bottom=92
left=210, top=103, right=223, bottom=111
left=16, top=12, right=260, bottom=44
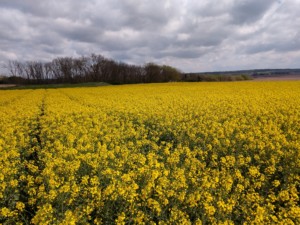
left=0, top=81, right=300, bottom=224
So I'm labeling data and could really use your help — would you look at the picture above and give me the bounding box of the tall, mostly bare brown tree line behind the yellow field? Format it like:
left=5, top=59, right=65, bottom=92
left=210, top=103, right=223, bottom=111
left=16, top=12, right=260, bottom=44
left=6, top=54, right=182, bottom=84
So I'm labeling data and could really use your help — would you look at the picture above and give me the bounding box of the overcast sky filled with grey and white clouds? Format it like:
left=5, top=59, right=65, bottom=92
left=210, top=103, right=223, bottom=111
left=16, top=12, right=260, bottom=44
left=0, top=0, right=300, bottom=72
